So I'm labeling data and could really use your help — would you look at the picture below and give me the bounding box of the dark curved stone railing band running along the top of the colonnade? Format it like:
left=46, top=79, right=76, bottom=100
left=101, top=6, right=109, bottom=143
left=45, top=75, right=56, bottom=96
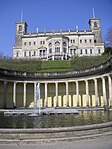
left=0, top=57, right=112, bottom=80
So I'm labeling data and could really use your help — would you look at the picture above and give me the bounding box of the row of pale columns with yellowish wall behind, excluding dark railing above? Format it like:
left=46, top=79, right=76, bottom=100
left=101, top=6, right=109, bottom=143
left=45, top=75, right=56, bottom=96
left=0, top=74, right=112, bottom=108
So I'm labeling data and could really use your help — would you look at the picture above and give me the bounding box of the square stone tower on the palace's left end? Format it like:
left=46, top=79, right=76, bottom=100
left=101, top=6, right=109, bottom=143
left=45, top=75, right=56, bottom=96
left=15, top=22, right=27, bottom=46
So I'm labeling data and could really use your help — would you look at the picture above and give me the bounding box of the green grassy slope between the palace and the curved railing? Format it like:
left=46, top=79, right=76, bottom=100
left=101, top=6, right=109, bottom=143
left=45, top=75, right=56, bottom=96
left=0, top=55, right=109, bottom=72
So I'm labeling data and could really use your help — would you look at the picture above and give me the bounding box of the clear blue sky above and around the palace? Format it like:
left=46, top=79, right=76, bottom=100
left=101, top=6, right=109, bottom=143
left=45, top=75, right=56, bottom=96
left=0, top=0, right=112, bottom=57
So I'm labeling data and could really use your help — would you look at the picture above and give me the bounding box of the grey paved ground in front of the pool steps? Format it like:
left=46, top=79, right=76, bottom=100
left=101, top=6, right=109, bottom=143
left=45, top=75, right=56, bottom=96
left=0, top=136, right=112, bottom=149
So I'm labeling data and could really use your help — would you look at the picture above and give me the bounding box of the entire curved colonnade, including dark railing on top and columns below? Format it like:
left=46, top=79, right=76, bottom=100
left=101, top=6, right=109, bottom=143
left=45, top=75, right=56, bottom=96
left=0, top=58, right=112, bottom=108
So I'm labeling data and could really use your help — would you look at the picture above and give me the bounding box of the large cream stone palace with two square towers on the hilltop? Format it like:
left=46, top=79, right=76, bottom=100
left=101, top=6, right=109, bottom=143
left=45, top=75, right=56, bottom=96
left=13, top=17, right=104, bottom=60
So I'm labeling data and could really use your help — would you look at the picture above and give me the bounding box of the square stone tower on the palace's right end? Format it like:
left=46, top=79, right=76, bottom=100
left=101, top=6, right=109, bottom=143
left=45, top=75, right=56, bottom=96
left=89, top=17, right=102, bottom=43
